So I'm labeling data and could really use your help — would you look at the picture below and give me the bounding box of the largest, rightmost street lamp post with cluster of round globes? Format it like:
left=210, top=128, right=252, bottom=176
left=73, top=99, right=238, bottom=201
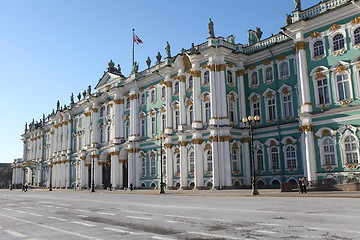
left=241, top=115, right=260, bottom=195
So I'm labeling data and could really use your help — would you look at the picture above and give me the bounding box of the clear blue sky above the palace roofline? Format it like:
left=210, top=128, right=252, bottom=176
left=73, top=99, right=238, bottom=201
left=0, top=0, right=319, bottom=162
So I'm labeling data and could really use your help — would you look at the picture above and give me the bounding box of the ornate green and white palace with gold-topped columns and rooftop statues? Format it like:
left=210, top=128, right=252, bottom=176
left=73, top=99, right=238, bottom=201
left=12, top=0, right=360, bottom=189
